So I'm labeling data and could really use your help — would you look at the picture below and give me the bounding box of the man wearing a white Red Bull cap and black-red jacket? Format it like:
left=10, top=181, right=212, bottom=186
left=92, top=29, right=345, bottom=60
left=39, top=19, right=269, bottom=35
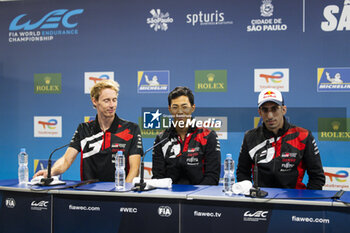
left=237, top=89, right=325, bottom=189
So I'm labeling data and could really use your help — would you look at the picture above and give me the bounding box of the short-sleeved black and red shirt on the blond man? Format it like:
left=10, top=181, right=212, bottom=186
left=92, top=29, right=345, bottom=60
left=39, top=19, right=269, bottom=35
left=70, top=115, right=143, bottom=181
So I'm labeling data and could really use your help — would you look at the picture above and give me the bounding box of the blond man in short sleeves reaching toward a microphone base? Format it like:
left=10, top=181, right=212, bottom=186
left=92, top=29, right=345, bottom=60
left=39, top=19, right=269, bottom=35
left=34, top=80, right=143, bottom=182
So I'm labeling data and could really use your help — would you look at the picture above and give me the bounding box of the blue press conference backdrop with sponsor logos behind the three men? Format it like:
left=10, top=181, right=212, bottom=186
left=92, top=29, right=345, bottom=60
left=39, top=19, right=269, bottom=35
left=0, top=0, right=350, bottom=189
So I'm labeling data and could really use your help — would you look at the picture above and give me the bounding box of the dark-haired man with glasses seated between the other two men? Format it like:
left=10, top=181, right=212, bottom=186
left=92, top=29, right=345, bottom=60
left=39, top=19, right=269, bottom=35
left=152, top=87, right=221, bottom=185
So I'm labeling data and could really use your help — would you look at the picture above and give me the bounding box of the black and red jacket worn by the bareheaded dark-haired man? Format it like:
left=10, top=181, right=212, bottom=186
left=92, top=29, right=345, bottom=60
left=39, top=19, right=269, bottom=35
left=152, top=127, right=221, bottom=185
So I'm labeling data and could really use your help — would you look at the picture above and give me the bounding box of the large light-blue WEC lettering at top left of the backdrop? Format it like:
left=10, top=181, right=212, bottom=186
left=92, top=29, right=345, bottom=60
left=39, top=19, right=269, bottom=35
left=9, top=9, right=84, bottom=31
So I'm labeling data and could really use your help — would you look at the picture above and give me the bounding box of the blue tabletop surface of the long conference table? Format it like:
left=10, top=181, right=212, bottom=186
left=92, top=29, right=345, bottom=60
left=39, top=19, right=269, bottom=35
left=0, top=179, right=350, bottom=207
